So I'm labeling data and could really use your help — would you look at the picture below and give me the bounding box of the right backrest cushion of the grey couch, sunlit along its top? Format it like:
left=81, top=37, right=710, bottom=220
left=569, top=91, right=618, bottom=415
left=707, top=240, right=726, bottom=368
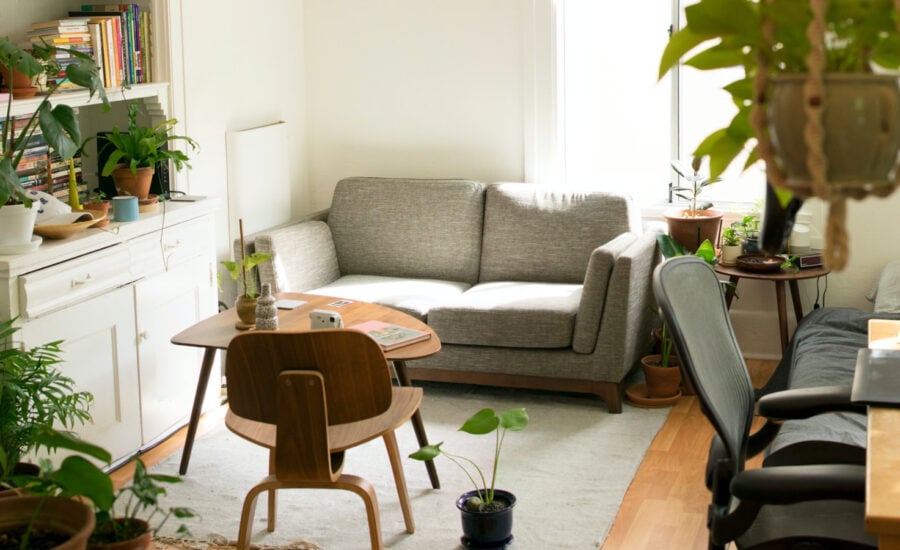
left=479, top=183, right=640, bottom=283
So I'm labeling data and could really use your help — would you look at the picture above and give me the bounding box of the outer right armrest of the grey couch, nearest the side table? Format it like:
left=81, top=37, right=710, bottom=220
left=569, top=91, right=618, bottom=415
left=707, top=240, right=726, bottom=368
left=594, top=233, right=660, bottom=380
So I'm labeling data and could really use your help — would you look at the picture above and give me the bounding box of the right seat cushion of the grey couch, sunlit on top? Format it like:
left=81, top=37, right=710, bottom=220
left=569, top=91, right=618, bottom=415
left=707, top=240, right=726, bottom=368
left=428, top=282, right=581, bottom=348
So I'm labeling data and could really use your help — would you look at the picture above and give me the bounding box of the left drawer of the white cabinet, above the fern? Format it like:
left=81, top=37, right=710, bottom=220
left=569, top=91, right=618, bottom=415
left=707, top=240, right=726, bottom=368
left=19, top=245, right=133, bottom=318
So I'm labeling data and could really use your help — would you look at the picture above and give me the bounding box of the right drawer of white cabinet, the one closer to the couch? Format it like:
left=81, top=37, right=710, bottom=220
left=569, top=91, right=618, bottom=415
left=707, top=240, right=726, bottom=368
left=129, top=216, right=213, bottom=279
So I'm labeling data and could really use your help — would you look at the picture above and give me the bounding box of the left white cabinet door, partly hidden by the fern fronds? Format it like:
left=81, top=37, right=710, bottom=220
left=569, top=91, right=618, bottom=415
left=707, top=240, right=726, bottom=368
left=20, top=286, right=141, bottom=468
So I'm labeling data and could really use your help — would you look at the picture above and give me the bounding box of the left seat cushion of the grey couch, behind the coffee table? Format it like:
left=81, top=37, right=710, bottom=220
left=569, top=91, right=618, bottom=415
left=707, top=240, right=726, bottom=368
left=307, top=275, right=469, bottom=321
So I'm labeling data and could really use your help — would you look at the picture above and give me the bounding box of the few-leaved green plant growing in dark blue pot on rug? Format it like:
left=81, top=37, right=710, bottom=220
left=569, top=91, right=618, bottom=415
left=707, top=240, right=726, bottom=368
left=409, top=408, right=528, bottom=511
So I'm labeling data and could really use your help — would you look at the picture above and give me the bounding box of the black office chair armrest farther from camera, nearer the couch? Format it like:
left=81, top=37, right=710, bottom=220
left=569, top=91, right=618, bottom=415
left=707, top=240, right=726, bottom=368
left=757, top=386, right=866, bottom=420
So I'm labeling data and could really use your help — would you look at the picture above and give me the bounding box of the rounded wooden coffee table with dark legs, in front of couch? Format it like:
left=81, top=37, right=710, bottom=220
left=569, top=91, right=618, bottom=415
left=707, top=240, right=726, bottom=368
left=172, top=292, right=441, bottom=489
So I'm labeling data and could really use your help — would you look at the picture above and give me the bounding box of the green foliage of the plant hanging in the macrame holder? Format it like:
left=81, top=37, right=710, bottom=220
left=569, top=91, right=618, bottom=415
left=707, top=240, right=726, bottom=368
left=659, top=0, right=900, bottom=182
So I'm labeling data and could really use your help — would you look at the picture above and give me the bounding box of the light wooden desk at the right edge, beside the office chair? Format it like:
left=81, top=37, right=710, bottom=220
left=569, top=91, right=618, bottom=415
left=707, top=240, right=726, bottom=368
left=866, top=320, right=900, bottom=550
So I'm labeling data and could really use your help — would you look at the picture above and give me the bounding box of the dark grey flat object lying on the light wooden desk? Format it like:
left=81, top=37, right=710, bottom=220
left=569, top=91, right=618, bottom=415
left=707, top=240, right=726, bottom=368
left=850, top=348, right=900, bottom=407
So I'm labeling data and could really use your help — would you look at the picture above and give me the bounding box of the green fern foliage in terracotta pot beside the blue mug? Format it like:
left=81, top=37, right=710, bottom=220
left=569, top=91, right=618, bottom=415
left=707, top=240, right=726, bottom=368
left=102, top=101, right=198, bottom=176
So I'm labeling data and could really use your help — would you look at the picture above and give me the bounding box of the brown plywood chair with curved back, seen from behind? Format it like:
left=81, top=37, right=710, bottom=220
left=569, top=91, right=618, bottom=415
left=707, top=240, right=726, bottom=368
left=225, top=330, right=422, bottom=549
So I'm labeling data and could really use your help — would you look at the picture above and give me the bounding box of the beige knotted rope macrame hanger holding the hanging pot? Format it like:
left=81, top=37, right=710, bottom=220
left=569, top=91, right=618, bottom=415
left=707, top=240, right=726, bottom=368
left=750, top=0, right=900, bottom=271
